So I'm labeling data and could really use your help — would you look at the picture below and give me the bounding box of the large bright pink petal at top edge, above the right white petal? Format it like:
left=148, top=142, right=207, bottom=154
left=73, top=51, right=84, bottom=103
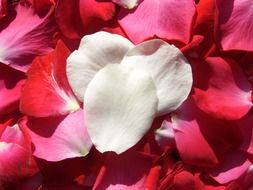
left=119, top=0, right=195, bottom=43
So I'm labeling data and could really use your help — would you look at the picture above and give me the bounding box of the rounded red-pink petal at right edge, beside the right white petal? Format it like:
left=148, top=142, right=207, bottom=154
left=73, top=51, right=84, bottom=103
left=194, top=57, right=253, bottom=120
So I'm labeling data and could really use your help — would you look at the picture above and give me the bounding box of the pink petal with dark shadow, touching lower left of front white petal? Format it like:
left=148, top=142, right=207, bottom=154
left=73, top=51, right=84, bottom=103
left=21, top=109, right=92, bottom=161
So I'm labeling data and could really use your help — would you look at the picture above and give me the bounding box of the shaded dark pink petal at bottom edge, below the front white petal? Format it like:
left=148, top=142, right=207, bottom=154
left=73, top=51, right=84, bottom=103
left=93, top=152, right=153, bottom=190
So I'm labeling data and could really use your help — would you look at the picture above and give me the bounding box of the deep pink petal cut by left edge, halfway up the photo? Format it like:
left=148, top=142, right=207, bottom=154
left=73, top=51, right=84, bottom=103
left=0, top=64, right=25, bottom=114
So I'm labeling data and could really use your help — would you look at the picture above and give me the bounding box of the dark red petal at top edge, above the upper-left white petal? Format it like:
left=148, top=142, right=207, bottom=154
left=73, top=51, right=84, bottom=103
left=55, top=0, right=115, bottom=39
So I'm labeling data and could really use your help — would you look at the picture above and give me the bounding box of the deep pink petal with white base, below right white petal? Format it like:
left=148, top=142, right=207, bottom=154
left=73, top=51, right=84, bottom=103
left=172, top=99, right=218, bottom=167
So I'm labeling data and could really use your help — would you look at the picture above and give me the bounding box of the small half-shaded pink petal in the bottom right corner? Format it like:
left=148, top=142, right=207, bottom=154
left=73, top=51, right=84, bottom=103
left=211, top=151, right=252, bottom=184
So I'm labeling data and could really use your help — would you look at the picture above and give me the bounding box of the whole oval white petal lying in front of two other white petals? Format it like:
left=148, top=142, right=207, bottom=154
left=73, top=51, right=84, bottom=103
left=84, top=64, right=158, bottom=154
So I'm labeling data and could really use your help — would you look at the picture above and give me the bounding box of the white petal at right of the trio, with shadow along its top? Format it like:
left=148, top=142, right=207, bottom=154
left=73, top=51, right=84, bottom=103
left=121, top=39, right=192, bottom=115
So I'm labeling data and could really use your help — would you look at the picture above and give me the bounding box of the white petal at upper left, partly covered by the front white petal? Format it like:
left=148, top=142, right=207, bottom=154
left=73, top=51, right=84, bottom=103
left=67, top=32, right=134, bottom=101
